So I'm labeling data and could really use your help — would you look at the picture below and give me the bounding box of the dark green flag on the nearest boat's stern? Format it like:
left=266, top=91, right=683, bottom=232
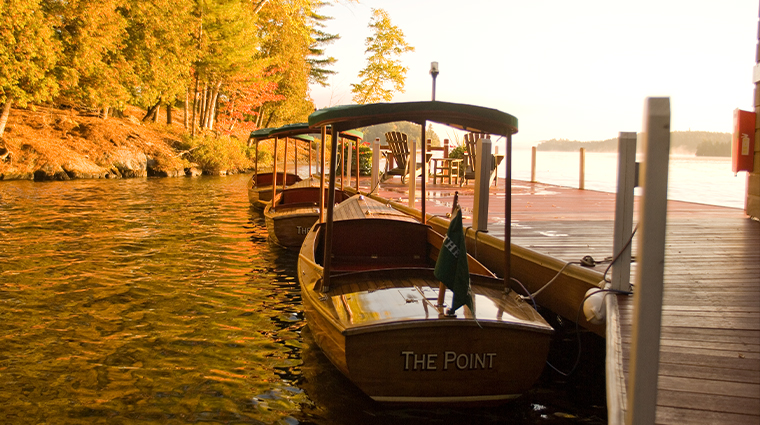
left=434, top=209, right=472, bottom=314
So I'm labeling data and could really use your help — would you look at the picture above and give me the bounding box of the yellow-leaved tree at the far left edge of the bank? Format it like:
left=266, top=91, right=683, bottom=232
left=0, top=0, right=60, bottom=136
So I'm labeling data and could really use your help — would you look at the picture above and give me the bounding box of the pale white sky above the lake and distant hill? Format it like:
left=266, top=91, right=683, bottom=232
left=311, top=0, right=760, bottom=146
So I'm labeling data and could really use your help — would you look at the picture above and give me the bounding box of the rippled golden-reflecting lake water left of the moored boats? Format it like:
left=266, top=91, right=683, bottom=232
left=0, top=175, right=606, bottom=425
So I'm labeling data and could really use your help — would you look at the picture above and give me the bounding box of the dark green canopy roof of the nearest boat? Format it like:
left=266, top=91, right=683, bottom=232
left=309, top=101, right=517, bottom=136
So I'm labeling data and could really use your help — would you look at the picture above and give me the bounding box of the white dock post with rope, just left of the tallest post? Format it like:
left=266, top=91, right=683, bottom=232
left=612, top=132, right=636, bottom=291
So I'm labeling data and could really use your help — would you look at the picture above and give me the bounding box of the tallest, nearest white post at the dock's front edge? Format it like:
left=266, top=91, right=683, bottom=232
left=625, top=97, right=670, bottom=425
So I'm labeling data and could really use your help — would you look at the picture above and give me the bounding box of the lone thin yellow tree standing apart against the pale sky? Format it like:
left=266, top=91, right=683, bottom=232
left=351, top=9, right=414, bottom=104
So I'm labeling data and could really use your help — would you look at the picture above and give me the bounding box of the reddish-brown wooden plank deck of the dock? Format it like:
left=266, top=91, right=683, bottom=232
left=362, top=179, right=760, bottom=424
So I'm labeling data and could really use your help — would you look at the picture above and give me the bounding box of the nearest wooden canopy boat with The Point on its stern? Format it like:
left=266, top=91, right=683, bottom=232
left=298, top=102, right=553, bottom=405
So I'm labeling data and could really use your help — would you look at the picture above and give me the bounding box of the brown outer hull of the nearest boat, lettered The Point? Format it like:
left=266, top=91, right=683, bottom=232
left=304, top=284, right=550, bottom=405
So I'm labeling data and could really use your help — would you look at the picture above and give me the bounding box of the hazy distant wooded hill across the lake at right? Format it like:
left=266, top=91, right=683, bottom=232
left=536, top=131, right=731, bottom=156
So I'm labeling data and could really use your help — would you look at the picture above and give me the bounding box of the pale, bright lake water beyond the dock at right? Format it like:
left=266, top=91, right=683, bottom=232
left=501, top=147, right=747, bottom=208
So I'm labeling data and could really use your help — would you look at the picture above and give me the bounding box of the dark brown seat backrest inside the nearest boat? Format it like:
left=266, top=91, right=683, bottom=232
left=332, top=219, right=429, bottom=271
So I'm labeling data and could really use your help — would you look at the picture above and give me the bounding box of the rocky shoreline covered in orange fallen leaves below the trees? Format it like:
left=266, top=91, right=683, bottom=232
left=0, top=108, right=251, bottom=181
